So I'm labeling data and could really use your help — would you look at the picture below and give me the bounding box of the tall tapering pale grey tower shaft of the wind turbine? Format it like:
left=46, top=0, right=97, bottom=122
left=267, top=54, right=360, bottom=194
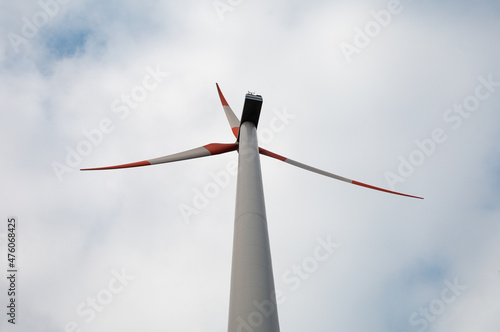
left=228, top=121, right=279, bottom=332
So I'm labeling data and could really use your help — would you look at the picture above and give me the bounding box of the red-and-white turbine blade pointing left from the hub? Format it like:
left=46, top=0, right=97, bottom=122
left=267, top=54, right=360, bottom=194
left=81, top=143, right=238, bottom=171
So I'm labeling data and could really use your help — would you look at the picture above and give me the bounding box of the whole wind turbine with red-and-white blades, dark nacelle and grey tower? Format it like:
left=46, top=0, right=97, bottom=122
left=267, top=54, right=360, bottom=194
left=82, top=84, right=422, bottom=332
